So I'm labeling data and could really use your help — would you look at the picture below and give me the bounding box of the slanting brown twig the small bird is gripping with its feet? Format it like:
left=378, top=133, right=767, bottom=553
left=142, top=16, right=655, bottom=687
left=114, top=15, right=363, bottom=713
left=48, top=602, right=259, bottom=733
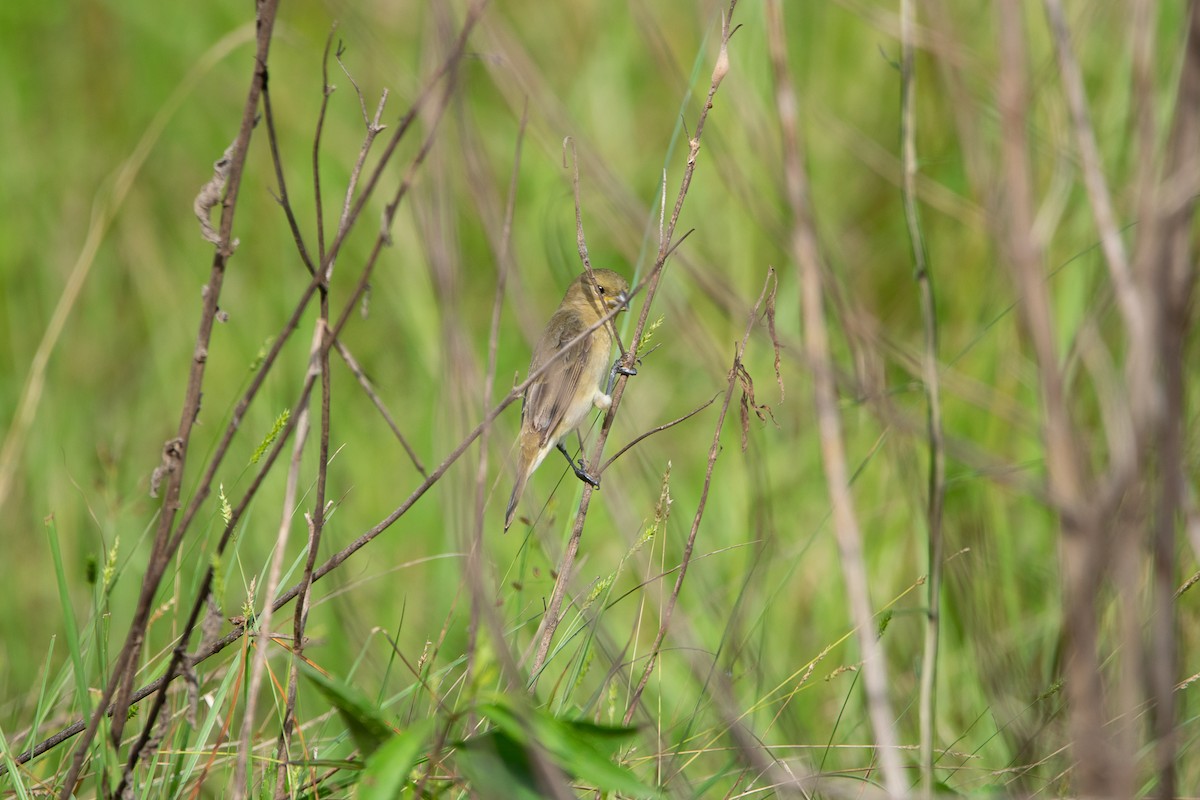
left=529, top=0, right=737, bottom=690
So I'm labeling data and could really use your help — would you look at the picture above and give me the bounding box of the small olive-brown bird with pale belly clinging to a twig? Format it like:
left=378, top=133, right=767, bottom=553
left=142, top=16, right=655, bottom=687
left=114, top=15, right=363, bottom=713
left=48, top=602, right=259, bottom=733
left=504, top=270, right=632, bottom=530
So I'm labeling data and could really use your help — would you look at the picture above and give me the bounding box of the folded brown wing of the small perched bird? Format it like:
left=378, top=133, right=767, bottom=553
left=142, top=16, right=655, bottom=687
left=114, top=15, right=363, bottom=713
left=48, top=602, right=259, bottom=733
left=522, top=309, right=594, bottom=445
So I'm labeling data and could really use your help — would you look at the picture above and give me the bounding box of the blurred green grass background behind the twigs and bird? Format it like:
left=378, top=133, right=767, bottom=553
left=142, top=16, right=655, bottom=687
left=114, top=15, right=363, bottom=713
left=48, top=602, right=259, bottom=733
left=0, top=0, right=1200, bottom=794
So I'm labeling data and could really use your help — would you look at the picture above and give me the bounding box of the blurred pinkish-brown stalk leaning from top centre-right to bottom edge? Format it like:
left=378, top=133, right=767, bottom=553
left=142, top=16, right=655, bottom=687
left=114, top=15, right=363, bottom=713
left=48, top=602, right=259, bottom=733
left=767, top=0, right=908, bottom=798
